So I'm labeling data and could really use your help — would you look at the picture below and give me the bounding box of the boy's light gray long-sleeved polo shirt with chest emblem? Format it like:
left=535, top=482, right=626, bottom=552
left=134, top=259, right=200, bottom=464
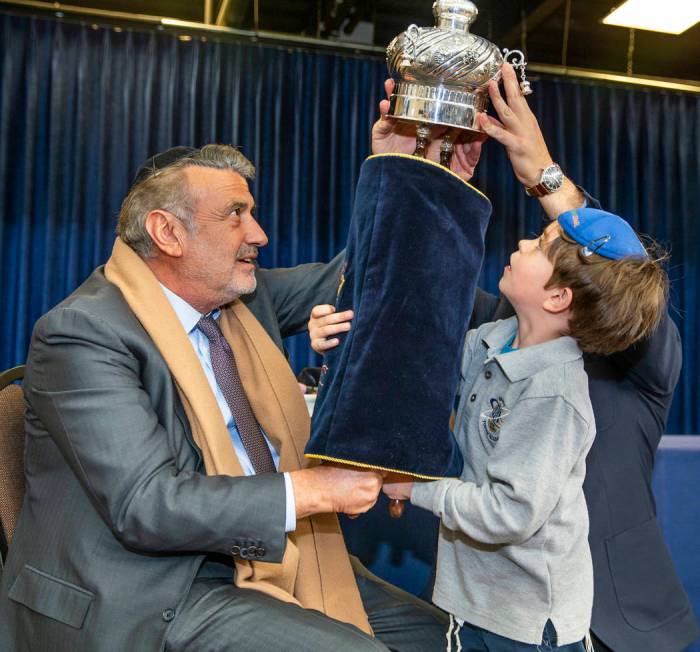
left=411, top=317, right=595, bottom=645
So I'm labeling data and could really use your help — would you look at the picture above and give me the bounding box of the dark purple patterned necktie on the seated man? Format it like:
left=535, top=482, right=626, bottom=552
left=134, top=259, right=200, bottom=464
left=197, top=315, right=277, bottom=473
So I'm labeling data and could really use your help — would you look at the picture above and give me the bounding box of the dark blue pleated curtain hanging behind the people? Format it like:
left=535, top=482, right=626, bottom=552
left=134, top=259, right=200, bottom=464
left=0, top=14, right=700, bottom=433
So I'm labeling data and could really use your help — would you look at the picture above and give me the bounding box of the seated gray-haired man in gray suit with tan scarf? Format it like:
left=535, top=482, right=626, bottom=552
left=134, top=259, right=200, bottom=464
left=0, top=140, right=442, bottom=652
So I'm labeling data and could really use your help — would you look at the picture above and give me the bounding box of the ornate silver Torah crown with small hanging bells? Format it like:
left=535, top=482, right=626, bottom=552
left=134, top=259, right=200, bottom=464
left=386, top=0, right=532, bottom=131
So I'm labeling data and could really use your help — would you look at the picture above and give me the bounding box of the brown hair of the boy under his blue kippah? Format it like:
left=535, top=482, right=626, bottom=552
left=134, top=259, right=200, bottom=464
left=545, top=233, right=668, bottom=355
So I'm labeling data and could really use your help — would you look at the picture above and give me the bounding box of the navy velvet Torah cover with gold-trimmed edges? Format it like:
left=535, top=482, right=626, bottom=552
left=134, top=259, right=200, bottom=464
left=306, top=154, right=491, bottom=479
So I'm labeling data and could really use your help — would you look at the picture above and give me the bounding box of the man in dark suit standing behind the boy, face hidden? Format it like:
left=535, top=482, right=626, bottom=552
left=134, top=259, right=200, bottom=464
left=309, top=65, right=700, bottom=652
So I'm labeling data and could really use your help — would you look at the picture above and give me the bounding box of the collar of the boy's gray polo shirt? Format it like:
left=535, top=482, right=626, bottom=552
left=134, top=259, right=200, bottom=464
left=481, top=317, right=583, bottom=382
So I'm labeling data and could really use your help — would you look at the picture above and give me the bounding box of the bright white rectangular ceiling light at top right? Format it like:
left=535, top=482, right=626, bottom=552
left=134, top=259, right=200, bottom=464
left=603, top=0, right=700, bottom=34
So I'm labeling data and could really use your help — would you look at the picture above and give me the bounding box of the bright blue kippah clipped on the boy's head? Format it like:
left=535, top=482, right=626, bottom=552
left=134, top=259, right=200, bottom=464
left=557, top=208, right=648, bottom=260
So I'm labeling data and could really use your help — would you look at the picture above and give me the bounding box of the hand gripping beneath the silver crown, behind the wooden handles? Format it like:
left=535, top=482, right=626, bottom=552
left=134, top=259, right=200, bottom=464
left=372, top=79, right=487, bottom=181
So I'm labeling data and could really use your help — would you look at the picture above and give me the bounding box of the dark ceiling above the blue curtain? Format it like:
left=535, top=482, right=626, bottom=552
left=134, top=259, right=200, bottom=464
left=9, top=0, right=700, bottom=81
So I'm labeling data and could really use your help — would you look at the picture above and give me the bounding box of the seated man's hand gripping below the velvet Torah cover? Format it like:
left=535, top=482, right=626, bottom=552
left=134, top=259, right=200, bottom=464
left=290, top=464, right=382, bottom=519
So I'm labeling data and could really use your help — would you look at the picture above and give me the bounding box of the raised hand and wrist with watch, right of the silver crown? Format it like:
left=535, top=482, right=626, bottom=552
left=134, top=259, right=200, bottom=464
left=478, top=63, right=584, bottom=219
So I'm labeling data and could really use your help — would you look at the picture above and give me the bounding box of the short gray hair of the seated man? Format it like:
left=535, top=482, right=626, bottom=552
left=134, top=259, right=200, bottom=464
left=117, top=144, right=255, bottom=258
